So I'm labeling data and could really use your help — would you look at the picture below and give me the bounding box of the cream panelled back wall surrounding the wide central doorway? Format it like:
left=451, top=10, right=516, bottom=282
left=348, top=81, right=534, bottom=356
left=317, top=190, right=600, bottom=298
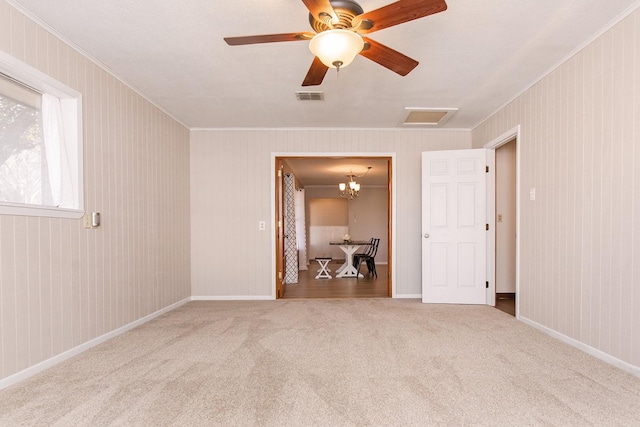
left=191, top=130, right=471, bottom=297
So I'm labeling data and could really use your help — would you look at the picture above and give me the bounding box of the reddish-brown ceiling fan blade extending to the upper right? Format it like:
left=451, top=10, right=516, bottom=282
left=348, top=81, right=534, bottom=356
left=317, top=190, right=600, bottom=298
left=352, top=0, right=447, bottom=34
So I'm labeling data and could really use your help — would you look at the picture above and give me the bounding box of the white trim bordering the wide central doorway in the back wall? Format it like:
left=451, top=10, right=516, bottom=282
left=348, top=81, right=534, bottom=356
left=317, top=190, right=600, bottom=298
left=269, top=151, right=397, bottom=299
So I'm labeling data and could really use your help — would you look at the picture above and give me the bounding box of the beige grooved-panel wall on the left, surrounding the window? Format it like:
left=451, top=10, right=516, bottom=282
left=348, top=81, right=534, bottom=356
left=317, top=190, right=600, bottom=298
left=0, top=1, right=190, bottom=379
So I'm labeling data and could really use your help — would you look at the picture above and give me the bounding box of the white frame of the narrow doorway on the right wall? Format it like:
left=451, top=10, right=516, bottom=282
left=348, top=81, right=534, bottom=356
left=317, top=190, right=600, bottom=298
left=483, top=125, right=522, bottom=319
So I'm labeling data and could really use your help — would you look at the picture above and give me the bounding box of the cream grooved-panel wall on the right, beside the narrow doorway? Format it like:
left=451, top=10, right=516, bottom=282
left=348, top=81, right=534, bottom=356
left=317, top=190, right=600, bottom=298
left=473, top=10, right=640, bottom=367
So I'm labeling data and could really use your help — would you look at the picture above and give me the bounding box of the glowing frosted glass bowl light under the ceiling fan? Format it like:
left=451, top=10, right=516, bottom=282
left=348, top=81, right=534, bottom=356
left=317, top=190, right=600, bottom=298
left=309, top=29, right=364, bottom=69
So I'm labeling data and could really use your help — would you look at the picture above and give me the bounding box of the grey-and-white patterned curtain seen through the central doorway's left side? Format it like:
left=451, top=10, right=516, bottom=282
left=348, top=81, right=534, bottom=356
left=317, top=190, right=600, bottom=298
left=284, top=173, right=298, bottom=284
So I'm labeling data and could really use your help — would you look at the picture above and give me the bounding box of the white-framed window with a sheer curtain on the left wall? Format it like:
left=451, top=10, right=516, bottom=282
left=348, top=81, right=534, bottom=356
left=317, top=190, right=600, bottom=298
left=0, top=52, right=84, bottom=218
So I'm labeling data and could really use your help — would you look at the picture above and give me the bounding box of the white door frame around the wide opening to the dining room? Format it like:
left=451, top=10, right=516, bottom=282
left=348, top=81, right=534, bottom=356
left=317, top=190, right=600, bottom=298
left=270, top=151, right=397, bottom=299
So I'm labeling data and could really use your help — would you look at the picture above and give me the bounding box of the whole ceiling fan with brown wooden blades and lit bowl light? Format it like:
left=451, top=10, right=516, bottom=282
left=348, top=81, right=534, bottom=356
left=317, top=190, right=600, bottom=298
left=224, top=0, right=447, bottom=86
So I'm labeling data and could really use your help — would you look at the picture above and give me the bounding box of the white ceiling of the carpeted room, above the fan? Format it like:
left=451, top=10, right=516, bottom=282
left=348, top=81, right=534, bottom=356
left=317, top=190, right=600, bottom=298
left=8, top=0, right=640, bottom=129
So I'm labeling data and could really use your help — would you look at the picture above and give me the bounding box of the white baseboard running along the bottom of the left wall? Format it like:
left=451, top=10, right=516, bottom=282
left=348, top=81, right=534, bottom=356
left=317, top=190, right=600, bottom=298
left=0, top=298, right=191, bottom=390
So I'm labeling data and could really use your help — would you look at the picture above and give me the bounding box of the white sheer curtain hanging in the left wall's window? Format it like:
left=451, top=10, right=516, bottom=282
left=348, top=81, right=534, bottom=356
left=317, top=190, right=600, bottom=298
left=42, top=93, right=78, bottom=208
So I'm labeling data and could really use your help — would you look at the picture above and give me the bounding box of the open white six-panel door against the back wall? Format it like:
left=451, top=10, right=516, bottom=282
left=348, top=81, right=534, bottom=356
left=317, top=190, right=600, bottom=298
left=422, top=149, right=487, bottom=304
